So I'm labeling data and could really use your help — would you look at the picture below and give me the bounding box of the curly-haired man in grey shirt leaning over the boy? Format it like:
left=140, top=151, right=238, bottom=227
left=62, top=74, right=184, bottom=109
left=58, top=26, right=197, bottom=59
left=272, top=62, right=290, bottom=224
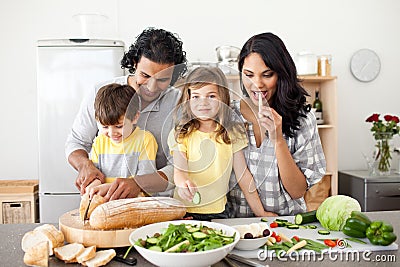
left=65, top=28, right=187, bottom=200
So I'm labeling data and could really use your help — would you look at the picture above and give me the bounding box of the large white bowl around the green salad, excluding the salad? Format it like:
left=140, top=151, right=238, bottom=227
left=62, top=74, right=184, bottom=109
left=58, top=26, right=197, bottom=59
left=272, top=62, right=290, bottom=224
left=129, top=220, right=240, bottom=267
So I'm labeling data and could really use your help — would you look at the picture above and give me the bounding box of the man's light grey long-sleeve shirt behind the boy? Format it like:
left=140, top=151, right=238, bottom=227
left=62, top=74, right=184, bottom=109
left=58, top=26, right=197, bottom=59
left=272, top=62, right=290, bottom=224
left=65, top=76, right=180, bottom=195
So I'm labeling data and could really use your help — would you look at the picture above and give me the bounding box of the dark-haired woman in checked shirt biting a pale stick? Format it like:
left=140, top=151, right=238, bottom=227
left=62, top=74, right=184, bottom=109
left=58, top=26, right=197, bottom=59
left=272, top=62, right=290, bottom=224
left=229, top=33, right=326, bottom=217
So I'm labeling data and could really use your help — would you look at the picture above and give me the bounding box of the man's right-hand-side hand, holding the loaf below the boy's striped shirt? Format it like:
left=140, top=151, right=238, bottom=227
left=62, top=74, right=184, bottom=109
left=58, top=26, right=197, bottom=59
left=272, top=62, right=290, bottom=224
left=104, top=178, right=141, bottom=201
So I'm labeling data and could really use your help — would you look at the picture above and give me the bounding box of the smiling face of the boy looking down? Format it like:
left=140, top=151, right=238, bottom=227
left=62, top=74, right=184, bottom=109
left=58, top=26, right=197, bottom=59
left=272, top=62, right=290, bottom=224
left=99, top=113, right=139, bottom=144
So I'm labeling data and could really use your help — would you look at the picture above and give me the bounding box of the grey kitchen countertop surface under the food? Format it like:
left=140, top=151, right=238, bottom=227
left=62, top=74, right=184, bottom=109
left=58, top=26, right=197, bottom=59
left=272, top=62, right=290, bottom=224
left=0, top=211, right=400, bottom=267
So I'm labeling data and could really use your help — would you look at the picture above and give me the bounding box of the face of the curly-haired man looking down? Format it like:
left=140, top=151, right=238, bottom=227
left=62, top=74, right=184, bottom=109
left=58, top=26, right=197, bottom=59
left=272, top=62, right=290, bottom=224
left=135, top=56, right=174, bottom=106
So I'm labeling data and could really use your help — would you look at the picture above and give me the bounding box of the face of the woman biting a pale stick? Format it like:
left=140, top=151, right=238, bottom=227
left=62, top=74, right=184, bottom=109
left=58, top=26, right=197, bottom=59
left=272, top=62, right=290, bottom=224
left=242, top=53, right=278, bottom=105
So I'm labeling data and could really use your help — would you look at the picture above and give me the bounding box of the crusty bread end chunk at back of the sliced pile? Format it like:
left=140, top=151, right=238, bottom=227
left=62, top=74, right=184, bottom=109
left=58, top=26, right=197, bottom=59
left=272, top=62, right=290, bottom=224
left=21, top=224, right=64, bottom=256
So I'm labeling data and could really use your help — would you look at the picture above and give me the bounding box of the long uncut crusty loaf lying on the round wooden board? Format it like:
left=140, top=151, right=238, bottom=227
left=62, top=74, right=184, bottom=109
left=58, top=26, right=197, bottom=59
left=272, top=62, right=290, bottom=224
left=89, top=197, right=186, bottom=230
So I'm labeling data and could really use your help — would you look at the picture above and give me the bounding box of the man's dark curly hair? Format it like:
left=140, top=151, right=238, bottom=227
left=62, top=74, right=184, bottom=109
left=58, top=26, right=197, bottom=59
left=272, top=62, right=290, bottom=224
left=121, top=28, right=187, bottom=85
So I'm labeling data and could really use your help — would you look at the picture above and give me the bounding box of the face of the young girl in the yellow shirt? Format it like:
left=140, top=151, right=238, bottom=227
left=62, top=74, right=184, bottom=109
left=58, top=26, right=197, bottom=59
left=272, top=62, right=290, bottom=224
left=189, top=84, right=221, bottom=120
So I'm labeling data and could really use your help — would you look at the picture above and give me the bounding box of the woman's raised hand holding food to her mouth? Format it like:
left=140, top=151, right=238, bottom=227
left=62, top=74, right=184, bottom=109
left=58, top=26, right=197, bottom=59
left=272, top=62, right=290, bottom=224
left=258, top=107, right=283, bottom=144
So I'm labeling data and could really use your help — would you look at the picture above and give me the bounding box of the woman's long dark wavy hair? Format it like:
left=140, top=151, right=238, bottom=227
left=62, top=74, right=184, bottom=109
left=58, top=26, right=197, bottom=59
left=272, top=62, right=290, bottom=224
left=238, top=32, right=310, bottom=137
